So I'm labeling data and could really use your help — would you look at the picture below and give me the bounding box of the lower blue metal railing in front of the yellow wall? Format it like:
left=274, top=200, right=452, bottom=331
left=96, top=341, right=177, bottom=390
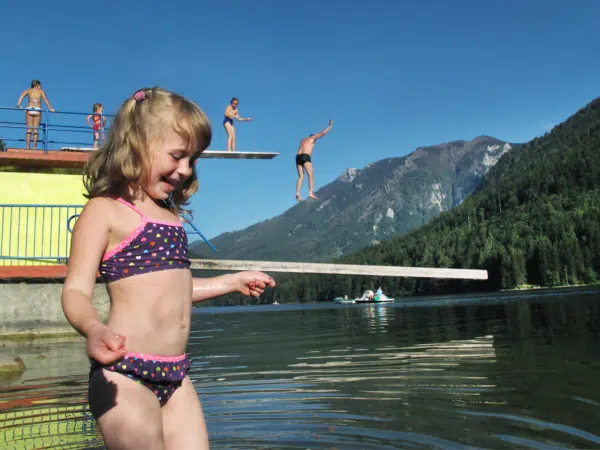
left=0, top=204, right=217, bottom=266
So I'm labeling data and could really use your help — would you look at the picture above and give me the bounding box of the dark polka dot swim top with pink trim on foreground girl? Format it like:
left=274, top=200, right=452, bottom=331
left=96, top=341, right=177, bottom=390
left=99, top=198, right=190, bottom=283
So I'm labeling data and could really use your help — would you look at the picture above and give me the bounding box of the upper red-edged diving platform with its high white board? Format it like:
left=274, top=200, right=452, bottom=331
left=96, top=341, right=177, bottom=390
left=0, top=147, right=279, bottom=169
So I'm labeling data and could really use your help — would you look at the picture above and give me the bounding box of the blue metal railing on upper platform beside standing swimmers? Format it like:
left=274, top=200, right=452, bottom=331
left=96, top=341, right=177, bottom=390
left=0, top=106, right=114, bottom=152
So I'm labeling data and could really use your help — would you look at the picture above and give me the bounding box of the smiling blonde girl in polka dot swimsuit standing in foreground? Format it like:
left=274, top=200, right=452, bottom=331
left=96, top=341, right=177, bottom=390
left=62, top=88, right=275, bottom=450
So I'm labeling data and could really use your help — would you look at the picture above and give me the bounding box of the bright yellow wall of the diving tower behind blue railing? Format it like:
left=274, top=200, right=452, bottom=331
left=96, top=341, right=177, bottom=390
left=0, top=172, right=87, bottom=265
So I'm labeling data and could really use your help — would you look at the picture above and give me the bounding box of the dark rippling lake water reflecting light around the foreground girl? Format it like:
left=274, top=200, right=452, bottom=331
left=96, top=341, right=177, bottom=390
left=0, top=288, right=600, bottom=450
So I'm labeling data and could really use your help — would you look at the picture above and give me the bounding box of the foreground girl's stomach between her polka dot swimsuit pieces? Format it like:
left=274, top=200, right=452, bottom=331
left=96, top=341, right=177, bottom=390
left=107, top=269, right=192, bottom=356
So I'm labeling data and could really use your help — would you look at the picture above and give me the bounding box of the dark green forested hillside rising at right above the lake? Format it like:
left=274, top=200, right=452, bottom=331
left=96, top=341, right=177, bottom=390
left=255, top=99, right=600, bottom=302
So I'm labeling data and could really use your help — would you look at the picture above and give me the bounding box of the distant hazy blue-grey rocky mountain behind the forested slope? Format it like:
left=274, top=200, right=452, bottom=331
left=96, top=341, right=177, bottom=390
left=190, top=136, right=515, bottom=262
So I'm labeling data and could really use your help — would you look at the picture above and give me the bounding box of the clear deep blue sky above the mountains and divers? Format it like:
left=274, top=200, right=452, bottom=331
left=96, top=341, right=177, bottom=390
left=0, top=0, right=600, bottom=243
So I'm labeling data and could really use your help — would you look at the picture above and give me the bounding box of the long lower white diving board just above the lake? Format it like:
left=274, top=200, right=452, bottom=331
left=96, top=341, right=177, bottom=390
left=191, top=259, right=488, bottom=280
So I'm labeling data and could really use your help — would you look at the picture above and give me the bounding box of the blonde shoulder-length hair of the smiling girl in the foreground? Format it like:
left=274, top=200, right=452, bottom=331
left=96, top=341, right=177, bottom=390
left=83, top=87, right=212, bottom=214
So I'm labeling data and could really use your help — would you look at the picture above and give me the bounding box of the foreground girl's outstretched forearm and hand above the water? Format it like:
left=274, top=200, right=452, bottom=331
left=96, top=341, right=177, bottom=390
left=192, top=271, right=275, bottom=303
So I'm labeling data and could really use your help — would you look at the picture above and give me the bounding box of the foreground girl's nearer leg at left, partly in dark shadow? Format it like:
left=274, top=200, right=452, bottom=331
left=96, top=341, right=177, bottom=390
left=89, top=369, right=165, bottom=450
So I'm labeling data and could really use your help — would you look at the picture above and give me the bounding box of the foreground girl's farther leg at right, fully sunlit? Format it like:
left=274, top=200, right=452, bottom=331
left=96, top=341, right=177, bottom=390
left=162, top=377, right=209, bottom=450
